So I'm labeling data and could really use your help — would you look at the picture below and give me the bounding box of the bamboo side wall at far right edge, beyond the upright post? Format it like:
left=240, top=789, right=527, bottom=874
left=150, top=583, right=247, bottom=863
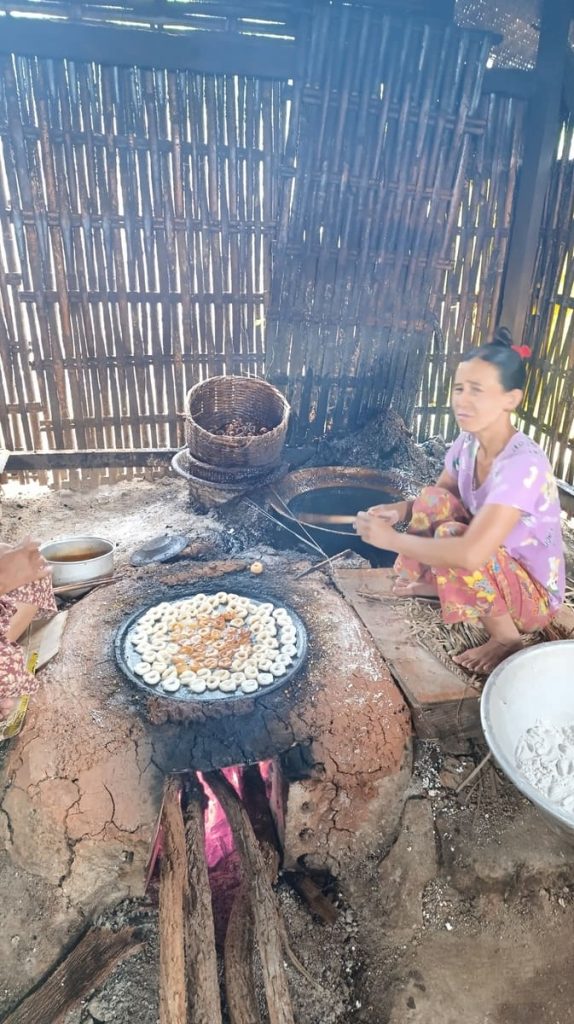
left=524, top=115, right=574, bottom=483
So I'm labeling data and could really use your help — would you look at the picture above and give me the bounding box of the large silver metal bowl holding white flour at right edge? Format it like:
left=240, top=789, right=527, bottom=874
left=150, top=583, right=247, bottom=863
left=481, top=640, right=574, bottom=840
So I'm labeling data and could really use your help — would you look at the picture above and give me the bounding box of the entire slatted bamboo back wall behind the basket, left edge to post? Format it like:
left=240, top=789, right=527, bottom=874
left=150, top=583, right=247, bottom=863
left=0, top=0, right=564, bottom=479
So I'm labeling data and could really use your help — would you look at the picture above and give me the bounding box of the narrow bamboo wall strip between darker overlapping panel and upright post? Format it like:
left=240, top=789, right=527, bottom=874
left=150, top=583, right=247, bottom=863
left=415, top=95, right=524, bottom=440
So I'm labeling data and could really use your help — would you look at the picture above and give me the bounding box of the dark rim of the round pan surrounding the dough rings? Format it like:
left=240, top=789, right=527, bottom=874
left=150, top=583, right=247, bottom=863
left=115, top=580, right=307, bottom=703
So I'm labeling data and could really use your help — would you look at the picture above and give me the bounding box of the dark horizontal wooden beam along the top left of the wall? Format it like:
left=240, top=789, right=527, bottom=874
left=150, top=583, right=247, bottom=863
left=0, top=15, right=298, bottom=79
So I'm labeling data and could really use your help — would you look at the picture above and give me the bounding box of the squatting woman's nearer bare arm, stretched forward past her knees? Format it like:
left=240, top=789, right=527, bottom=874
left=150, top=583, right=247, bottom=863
left=356, top=505, right=522, bottom=572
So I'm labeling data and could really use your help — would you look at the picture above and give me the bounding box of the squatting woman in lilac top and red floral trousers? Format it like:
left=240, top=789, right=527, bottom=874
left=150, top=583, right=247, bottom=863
left=356, top=328, right=565, bottom=673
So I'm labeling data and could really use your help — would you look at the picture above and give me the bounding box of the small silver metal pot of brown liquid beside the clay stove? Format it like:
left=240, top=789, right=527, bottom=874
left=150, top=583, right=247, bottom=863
left=40, top=537, right=114, bottom=597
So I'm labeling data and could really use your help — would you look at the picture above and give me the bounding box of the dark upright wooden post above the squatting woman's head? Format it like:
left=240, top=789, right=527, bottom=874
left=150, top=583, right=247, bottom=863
left=498, top=0, right=571, bottom=341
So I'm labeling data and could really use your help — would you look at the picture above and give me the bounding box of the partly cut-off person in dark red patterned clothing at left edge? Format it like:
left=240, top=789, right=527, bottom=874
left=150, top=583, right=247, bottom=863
left=0, top=541, right=56, bottom=720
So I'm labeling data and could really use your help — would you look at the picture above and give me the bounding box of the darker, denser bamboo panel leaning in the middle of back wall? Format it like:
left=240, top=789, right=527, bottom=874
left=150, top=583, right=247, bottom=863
left=267, top=8, right=489, bottom=439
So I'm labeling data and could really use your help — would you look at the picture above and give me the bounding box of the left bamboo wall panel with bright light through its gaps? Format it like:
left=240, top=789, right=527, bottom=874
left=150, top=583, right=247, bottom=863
left=0, top=57, right=285, bottom=449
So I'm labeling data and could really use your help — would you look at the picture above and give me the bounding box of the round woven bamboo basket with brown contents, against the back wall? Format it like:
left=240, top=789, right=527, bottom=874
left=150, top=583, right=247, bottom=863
left=185, top=376, right=290, bottom=467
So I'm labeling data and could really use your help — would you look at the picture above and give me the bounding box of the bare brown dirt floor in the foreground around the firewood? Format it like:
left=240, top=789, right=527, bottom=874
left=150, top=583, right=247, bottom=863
left=56, top=744, right=574, bottom=1024
